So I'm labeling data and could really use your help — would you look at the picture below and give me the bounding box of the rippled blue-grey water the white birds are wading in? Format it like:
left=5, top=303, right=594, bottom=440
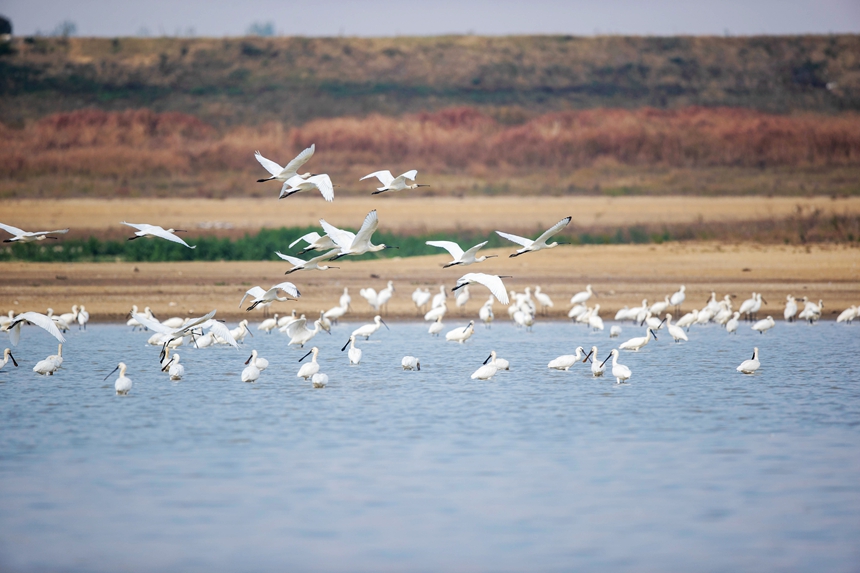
left=0, top=317, right=860, bottom=572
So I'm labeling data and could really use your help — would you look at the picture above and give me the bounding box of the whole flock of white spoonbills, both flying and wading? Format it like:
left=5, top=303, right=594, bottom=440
left=0, top=145, right=860, bottom=395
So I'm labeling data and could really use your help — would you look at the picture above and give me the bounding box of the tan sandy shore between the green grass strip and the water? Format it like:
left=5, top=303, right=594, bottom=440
left=0, top=243, right=860, bottom=321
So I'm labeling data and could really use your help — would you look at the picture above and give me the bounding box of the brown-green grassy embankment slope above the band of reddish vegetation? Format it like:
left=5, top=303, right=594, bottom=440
left=0, top=35, right=860, bottom=127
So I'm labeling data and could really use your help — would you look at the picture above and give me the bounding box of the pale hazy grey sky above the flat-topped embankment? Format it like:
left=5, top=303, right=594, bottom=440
left=0, top=0, right=860, bottom=36
